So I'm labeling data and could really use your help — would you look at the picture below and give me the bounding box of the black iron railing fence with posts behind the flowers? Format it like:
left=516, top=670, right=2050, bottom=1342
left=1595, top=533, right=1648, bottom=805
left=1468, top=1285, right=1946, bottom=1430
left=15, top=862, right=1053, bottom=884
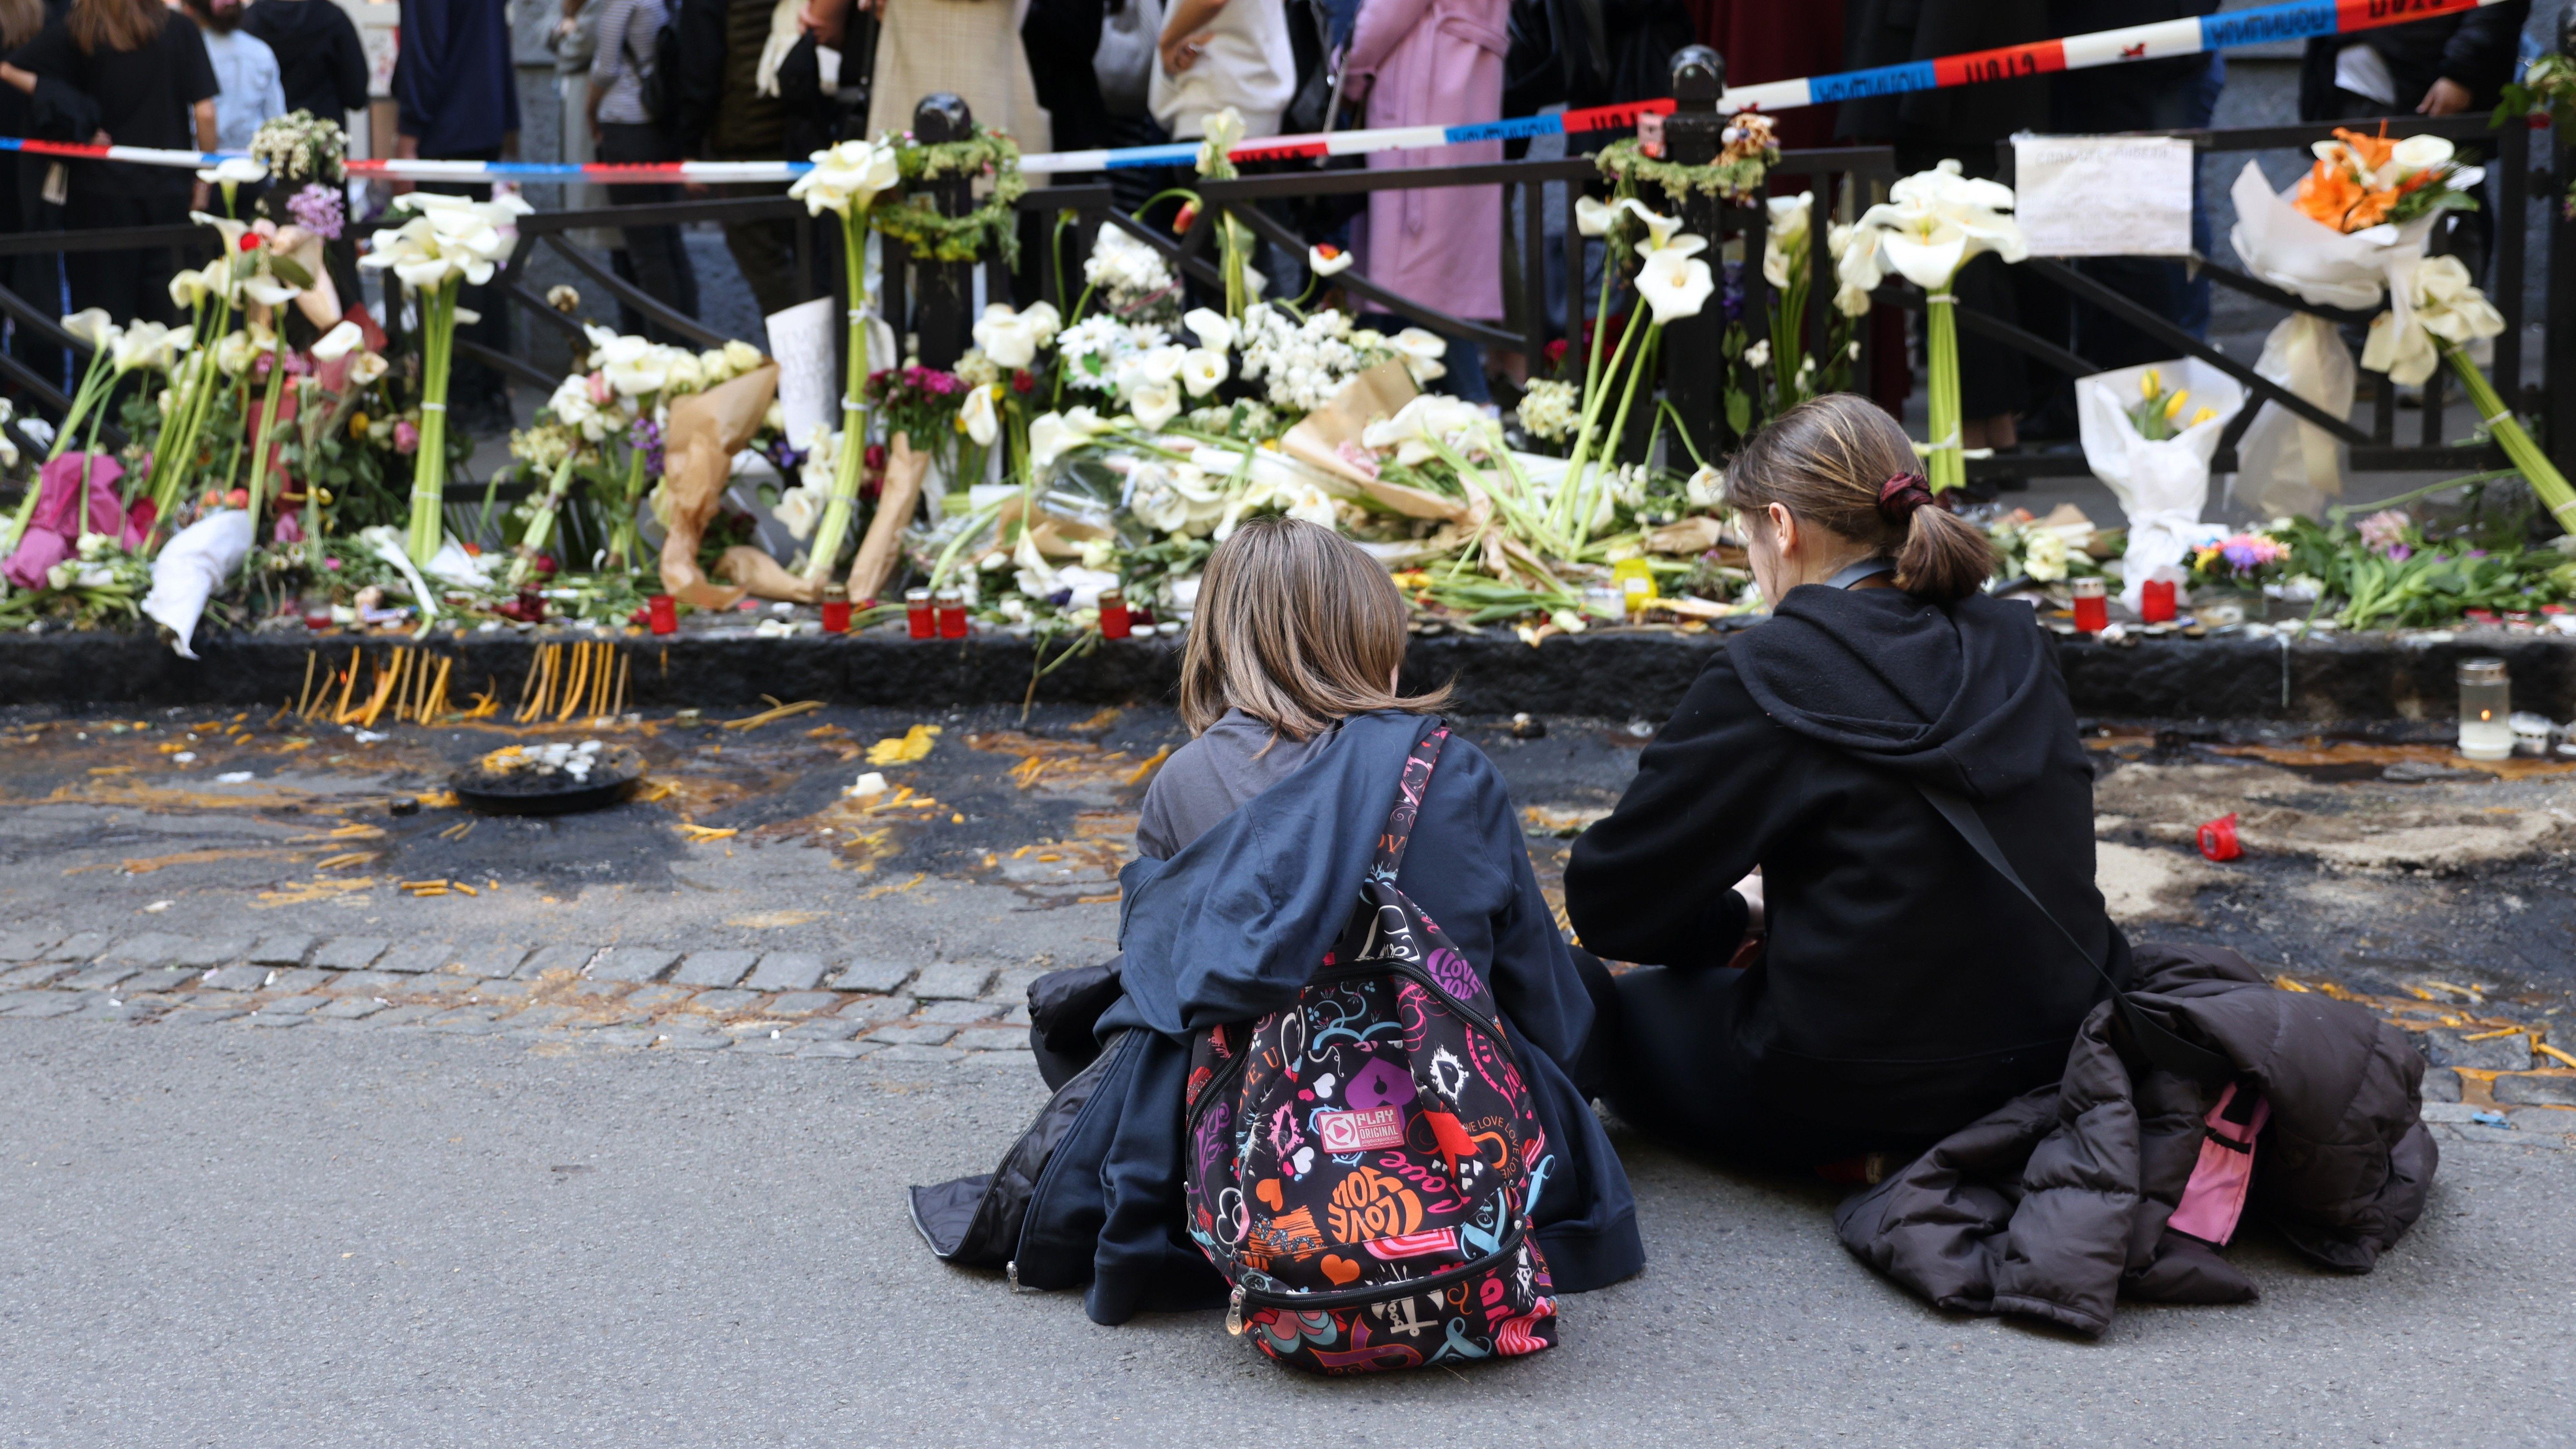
left=0, top=47, right=2576, bottom=502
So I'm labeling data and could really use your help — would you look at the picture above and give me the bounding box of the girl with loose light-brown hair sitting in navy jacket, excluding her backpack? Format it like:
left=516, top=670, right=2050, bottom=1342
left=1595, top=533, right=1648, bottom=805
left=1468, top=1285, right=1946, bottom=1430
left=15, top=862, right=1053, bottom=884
left=914, top=517, right=1643, bottom=1323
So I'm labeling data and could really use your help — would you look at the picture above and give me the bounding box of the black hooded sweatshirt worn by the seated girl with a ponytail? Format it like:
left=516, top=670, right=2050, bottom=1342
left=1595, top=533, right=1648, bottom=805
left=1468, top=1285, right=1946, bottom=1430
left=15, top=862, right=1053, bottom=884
left=1566, top=584, right=2128, bottom=1140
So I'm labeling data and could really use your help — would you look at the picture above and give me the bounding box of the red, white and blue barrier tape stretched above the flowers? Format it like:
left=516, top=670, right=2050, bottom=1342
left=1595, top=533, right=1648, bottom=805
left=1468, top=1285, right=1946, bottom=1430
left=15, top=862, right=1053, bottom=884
left=0, top=0, right=2504, bottom=185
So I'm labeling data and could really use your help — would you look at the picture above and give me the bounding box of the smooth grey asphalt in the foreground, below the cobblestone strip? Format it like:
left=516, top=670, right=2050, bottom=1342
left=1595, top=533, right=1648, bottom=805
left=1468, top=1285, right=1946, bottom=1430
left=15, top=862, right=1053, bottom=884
left=0, top=1022, right=2576, bottom=1449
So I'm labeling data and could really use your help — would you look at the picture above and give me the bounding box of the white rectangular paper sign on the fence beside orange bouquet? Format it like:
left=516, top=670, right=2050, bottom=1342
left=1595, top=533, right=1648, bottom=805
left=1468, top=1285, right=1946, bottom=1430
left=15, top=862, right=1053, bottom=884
left=2012, top=136, right=2192, bottom=257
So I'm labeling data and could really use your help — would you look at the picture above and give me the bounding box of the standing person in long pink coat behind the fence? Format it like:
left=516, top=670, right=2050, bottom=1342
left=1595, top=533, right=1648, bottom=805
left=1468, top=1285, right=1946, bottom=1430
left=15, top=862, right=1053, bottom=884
left=1345, top=0, right=1512, bottom=383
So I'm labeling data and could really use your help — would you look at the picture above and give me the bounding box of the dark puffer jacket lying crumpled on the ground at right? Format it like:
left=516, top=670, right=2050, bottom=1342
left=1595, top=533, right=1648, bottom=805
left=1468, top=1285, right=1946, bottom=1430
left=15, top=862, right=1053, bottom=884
left=1834, top=944, right=2439, bottom=1333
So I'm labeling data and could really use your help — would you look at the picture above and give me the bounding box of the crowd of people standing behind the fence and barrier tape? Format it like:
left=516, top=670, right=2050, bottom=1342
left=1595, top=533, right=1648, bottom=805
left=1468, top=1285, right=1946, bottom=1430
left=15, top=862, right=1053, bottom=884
left=0, top=0, right=2529, bottom=427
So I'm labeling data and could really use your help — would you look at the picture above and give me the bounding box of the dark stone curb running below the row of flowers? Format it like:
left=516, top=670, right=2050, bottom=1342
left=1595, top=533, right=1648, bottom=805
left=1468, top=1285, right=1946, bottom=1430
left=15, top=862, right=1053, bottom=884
left=0, top=628, right=2576, bottom=723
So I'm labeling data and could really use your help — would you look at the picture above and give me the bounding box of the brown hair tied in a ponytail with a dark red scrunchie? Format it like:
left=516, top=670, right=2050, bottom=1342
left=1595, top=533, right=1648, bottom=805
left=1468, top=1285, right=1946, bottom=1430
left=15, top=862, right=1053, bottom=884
left=1726, top=391, right=1994, bottom=605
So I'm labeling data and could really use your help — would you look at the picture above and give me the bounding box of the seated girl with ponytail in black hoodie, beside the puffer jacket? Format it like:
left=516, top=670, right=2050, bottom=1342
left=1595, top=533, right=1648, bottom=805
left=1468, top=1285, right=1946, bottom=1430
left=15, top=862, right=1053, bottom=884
left=1566, top=394, right=2130, bottom=1168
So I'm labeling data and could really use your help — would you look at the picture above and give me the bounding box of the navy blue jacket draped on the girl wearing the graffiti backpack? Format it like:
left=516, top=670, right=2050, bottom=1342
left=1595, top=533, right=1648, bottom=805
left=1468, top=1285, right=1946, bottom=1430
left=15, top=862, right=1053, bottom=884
left=1015, top=713, right=1646, bottom=1323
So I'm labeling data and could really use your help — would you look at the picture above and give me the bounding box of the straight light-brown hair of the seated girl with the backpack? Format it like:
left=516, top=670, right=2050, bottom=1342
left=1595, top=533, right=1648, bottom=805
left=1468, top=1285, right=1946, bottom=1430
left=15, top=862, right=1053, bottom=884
left=1180, top=517, right=1450, bottom=739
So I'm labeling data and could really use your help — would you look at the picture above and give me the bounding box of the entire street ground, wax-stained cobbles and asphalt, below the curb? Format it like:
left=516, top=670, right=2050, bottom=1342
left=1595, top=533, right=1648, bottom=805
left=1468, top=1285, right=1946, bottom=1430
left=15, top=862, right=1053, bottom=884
left=0, top=708, right=2576, bottom=1449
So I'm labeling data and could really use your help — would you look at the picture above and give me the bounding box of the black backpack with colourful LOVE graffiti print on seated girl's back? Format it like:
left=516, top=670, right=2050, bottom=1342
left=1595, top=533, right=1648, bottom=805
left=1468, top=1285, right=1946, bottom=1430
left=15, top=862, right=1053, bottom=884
left=1185, top=728, right=1556, bottom=1374
